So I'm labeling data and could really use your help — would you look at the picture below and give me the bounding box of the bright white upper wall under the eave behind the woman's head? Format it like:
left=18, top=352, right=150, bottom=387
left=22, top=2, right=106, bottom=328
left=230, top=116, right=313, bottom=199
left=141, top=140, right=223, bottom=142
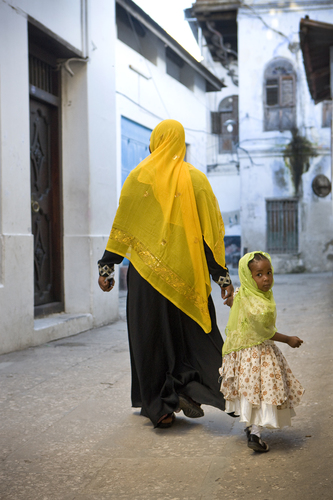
left=116, top=32, right=207, bottom=197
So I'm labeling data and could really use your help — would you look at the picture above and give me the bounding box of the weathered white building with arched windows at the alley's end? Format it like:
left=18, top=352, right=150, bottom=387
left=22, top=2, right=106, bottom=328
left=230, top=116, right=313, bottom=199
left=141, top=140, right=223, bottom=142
left=187, top=0, right=333, bottom=272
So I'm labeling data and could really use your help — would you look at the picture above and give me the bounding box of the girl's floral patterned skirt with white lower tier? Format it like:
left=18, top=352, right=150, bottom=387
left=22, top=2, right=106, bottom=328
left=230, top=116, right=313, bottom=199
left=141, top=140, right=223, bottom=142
left=220, top=340, right=304, bottom=428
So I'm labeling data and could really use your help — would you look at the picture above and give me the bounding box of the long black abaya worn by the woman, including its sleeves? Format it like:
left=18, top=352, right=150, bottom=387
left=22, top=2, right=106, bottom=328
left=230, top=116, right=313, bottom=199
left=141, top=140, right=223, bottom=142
left=99, top=245, right=227, bottom=427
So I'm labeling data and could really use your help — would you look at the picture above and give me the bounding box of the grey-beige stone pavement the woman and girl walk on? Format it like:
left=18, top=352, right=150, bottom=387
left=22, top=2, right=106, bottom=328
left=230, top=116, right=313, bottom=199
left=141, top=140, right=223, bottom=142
left=0, top=273, right=333, bottom=500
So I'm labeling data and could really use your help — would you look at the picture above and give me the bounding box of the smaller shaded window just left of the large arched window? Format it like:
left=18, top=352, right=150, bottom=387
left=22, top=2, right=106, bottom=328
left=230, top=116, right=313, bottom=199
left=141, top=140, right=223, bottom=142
left=211, top=95, right=238, bottom=153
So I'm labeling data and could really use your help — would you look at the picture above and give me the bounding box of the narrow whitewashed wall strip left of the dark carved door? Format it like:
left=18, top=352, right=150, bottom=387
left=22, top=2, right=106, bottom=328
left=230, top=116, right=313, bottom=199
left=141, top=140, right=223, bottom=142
left=0, top=2, right=33, bottom=352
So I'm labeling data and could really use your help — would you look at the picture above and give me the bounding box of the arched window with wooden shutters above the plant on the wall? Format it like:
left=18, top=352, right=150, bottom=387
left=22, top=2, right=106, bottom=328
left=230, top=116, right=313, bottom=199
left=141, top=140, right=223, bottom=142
left=264, top=58, right=296, bottom=131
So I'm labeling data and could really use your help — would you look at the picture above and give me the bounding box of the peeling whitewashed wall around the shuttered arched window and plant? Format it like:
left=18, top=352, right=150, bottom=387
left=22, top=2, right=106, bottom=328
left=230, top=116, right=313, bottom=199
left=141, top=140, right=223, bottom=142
left=238, top=2, right=333, bottom=272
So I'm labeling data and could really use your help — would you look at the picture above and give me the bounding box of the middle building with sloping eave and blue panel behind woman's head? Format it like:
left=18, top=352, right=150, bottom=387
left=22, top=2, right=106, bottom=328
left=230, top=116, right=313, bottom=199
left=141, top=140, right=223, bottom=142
left=116, top=0, right=223, bottom=289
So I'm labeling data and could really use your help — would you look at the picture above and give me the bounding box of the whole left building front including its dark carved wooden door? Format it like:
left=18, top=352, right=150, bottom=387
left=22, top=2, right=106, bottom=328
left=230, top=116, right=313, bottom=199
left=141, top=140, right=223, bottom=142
left=0, top=0, right=118, bottom=353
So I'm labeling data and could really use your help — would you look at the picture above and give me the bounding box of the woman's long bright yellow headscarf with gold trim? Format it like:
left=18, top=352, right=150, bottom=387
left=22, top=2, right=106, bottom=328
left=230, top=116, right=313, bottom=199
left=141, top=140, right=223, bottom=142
left=106, top=120, right=225, bottom=333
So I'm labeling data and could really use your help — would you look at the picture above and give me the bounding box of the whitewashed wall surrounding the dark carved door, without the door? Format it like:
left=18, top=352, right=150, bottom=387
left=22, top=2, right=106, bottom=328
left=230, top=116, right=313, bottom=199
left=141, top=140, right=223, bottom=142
left=0, top=0, right=118, bottom=352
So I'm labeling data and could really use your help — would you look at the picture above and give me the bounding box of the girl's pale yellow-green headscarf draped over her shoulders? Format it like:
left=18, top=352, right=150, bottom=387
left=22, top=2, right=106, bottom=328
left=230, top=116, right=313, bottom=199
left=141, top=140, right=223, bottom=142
left=222, top=251, right=276, bottom=356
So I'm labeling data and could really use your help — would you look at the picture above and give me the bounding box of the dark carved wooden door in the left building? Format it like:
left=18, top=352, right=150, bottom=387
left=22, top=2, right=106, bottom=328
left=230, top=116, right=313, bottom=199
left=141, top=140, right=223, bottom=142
left=30, top=99, right=62, bottom=315
